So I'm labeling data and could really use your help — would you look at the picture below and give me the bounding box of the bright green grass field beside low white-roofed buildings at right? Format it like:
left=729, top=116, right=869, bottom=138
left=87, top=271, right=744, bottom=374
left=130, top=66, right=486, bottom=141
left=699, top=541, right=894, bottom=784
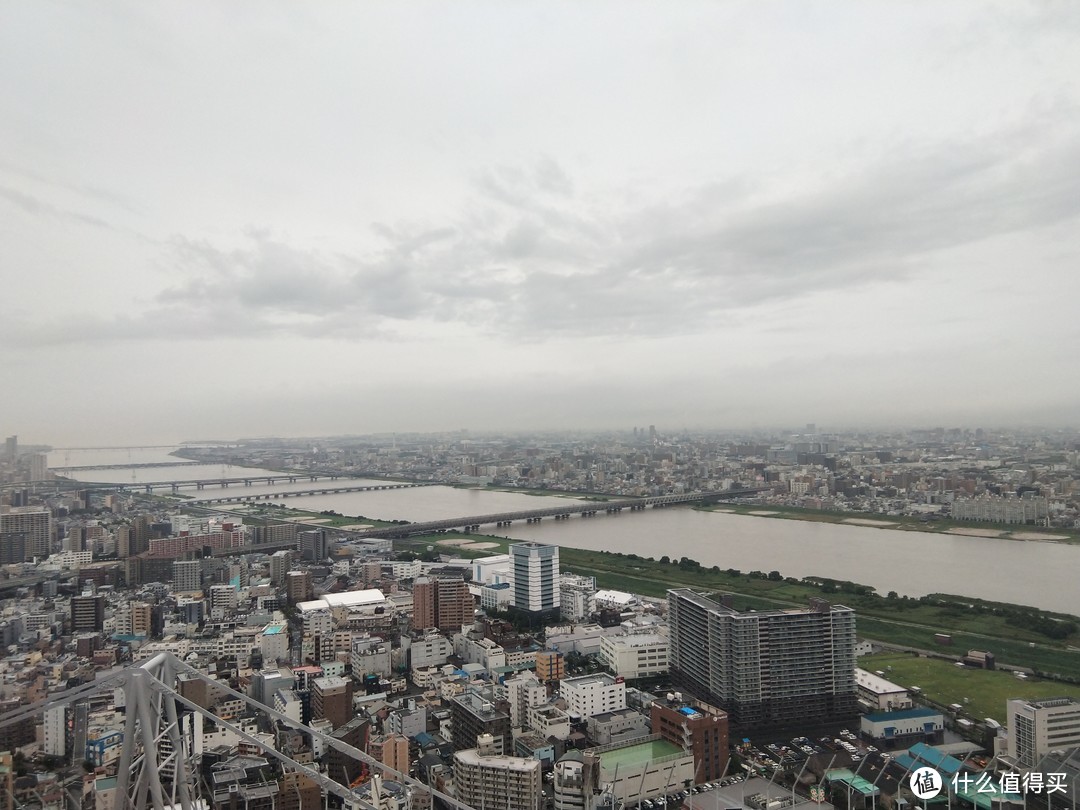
left=859, top=652, right=1080, bottom=723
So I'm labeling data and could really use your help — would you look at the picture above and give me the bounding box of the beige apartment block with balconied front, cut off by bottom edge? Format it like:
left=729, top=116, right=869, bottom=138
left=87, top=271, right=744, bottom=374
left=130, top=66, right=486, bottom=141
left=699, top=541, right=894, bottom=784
left=454, top=734, right=543, bottom=810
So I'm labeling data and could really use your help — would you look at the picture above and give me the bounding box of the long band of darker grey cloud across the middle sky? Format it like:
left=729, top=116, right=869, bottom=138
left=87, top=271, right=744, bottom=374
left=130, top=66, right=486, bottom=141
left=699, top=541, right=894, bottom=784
left=8, top=123, right=1080, bottom=343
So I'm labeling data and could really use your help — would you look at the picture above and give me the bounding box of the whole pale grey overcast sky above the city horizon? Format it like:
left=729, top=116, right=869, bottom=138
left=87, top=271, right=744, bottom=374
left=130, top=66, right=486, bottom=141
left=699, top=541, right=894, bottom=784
left=0, top=0, right=1080, bottom=446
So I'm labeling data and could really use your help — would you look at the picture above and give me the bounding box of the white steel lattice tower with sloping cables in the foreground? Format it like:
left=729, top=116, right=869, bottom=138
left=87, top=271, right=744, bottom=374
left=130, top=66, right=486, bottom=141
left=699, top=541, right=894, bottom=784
left=0, top=652, right=481, bottom=810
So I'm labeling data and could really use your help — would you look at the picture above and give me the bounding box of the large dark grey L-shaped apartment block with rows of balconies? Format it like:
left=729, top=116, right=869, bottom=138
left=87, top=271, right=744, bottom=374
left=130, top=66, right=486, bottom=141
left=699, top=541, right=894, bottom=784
left=667, top=589, right=858, bottom=731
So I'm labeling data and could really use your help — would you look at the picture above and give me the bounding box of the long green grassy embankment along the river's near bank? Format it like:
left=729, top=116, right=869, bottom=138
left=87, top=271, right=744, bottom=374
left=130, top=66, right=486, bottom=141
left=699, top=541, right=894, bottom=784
left=397, top=532, right=1080, bottom=686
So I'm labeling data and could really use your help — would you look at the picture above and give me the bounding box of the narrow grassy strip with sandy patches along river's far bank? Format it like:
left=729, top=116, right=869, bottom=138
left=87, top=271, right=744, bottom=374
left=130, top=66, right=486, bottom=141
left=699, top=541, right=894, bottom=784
left=694, top=501, right=1080, bottom=543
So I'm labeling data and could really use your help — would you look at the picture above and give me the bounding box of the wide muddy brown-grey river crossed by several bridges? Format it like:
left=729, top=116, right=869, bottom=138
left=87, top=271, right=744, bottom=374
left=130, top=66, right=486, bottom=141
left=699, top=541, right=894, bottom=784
left=56, top=449, right=1080, bottom=615
